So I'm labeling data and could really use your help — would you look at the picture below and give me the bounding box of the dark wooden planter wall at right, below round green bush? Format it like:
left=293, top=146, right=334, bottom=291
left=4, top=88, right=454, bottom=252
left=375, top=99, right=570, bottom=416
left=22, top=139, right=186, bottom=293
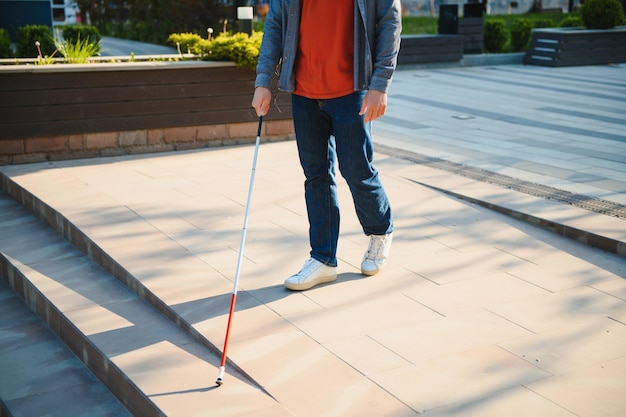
left=524, top=27, right=626, bottom=67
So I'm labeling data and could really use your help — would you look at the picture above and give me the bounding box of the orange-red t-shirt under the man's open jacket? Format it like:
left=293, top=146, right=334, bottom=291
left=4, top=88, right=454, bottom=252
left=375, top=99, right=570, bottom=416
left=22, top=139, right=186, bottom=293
left=294, top=0, right=354, bottom=99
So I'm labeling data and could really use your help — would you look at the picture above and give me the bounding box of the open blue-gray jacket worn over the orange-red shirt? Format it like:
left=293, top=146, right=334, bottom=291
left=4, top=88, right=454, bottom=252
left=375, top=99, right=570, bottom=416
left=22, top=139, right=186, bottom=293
left=255, top=0, right=402, bottom=92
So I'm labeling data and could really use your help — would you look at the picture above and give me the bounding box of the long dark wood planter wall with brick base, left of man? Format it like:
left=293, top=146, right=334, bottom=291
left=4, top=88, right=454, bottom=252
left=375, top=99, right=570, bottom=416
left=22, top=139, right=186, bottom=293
left=0, top=61, right=293, bottom=164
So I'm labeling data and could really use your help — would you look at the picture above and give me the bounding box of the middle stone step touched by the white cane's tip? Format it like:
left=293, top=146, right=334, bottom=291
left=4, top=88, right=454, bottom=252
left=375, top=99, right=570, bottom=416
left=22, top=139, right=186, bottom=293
left=0, top=191, right=287, bottom=416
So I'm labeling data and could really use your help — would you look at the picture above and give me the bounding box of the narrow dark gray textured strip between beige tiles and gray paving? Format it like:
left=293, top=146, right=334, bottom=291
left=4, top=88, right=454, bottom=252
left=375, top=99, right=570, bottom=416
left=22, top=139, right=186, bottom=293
left=376, top=144, right=626, bottom=219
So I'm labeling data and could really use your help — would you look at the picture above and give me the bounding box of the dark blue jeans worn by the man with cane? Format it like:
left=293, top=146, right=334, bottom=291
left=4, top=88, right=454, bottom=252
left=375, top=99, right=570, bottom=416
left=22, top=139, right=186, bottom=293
left=292, top=91, right=393, bottom=266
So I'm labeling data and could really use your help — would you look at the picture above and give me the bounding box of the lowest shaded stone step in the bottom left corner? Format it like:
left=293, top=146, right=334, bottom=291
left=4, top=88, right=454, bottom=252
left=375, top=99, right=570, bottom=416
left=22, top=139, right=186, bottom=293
left=0, top=280, right=131, bottom=417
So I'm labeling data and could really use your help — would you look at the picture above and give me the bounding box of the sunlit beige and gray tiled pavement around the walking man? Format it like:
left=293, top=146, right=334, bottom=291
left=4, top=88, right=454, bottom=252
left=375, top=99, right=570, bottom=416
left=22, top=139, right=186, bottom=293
left=0, top=65, right=626, bottom=417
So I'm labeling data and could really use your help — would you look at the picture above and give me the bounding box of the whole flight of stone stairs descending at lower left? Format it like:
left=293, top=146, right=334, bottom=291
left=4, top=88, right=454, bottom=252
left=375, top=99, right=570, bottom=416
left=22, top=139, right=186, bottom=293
left=0, top=177, right=288, bottom=417
